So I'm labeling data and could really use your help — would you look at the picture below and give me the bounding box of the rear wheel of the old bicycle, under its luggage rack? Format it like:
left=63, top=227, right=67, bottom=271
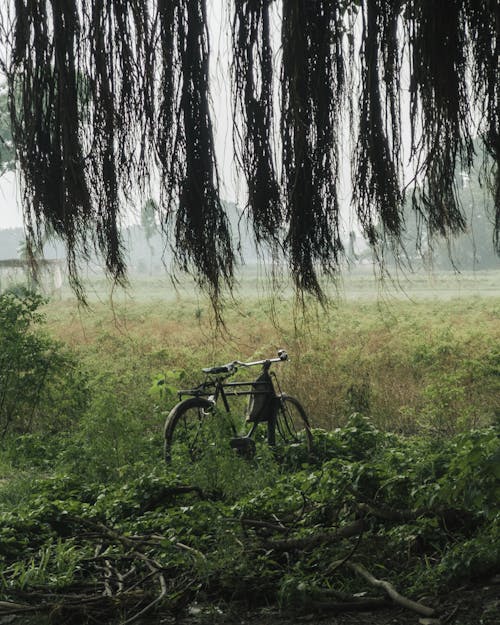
left=164, top=397, right=234, bottom=462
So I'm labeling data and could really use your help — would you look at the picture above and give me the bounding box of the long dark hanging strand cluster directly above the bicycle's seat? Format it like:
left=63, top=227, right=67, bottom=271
left=157, top=0, right=234, bottom=306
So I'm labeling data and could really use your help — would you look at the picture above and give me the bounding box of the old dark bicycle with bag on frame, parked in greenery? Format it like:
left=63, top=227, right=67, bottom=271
left=164, top=350, right=312, bottom=462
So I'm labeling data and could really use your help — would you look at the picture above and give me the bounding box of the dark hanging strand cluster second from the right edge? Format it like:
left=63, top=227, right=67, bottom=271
left=408, top=0, right=473, bottom=236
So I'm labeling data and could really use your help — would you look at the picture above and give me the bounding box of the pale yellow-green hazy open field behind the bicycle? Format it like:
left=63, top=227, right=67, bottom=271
left=42, top=269, right=500, bottom=434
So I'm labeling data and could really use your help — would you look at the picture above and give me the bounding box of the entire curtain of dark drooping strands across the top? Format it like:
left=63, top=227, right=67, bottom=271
left=3, top=0, right=500, bottom=302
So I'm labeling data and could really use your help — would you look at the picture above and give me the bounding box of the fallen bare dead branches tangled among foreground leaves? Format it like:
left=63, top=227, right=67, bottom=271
left=0, top=487, right=464, bottom=625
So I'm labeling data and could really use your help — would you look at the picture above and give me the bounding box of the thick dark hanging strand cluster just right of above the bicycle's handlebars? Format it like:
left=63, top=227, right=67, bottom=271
left=281, top=0, right=344, bottom=298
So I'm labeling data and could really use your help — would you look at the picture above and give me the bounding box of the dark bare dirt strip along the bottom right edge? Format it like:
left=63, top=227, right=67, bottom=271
left=172, top=575, right=500, bottom=625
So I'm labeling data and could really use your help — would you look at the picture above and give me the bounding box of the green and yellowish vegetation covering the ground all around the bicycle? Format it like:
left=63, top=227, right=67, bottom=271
left=0, top=286, right=500, bottom=625
